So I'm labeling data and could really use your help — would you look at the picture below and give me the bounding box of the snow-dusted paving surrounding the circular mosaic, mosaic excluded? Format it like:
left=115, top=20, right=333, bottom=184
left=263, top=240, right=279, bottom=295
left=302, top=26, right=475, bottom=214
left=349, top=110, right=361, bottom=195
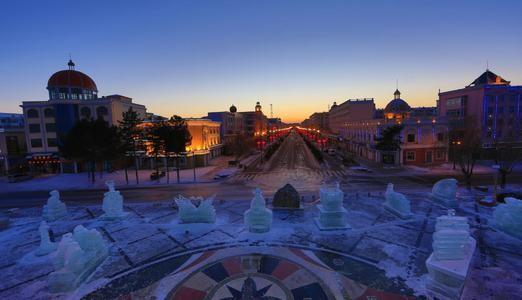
left=0, top=184, right=522, bottom=299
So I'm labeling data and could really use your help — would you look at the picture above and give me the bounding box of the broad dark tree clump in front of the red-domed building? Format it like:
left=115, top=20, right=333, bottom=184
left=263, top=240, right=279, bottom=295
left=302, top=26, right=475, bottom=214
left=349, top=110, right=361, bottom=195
left=60, top=118, right=122, bottom=182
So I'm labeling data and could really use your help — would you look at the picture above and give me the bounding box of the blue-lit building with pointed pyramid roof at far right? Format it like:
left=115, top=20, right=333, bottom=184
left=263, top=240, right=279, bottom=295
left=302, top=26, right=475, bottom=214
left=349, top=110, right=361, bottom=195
left=437, top=70, right=522, bottom=148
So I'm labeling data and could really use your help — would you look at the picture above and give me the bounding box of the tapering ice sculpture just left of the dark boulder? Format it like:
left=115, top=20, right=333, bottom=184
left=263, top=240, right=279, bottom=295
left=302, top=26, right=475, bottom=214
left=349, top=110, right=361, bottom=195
left=245, top=188, right=272, bottom=233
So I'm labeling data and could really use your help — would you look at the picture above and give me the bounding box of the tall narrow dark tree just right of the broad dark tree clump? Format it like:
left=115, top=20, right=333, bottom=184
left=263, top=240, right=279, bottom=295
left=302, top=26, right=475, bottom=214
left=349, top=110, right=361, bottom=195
left=118, top=107, right=143, bottom=184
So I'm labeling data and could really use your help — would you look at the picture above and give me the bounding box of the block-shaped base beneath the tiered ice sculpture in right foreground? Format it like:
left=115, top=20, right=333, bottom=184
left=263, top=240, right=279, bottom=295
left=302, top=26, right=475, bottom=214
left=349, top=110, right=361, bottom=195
left=426, top=238, right=477, bottom=299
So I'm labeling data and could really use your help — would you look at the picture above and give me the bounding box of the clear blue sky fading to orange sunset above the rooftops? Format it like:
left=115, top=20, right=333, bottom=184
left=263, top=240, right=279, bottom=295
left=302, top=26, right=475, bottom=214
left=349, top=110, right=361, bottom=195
left=0, top=0, right=522, bottom=122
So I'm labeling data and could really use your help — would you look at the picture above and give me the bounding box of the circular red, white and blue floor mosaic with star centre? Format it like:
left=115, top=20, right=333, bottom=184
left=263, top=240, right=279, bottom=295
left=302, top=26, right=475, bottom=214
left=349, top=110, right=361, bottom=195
left=169, top=254, right=332, bottom=300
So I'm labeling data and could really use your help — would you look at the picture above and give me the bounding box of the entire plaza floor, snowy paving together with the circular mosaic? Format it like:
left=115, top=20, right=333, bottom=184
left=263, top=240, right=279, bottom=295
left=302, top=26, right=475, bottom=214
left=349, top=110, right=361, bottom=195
left=0, top=189, right=522, bottom=299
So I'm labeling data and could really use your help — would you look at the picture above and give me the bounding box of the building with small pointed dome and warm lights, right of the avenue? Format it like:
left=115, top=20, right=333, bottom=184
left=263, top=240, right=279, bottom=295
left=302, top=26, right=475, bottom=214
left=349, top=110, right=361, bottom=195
left=342, top=90, right=448, bottom=166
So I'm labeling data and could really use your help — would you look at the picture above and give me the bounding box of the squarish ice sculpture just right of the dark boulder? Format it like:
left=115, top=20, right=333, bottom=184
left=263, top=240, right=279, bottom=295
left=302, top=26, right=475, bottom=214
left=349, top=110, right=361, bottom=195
left=315, top=183, right=350, bottom=230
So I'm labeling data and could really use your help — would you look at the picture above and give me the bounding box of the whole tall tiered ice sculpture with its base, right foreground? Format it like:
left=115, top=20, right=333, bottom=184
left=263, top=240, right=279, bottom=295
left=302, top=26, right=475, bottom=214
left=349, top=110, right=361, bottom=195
left=426, top=209, right=476, bottom=299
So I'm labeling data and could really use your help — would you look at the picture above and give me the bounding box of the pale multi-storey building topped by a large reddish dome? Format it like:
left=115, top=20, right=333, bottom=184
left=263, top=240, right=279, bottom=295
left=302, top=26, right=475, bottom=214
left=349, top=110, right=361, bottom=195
left=21, top=60, right=146, bottom=171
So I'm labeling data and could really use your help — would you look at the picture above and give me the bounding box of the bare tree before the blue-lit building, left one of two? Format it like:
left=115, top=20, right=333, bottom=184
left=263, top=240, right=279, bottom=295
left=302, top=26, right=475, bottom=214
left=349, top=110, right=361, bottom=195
left=456, top=116, right=482, bottom=189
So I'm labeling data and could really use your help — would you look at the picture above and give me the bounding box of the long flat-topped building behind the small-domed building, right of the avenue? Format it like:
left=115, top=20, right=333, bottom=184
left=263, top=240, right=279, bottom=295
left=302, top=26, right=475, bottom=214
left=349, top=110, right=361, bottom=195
left=328, top=98, right=375, bottom=134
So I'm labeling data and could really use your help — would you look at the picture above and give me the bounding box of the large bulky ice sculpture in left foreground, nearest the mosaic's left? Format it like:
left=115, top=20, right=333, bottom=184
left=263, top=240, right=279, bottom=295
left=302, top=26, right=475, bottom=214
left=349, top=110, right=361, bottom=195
left=49, top=225, right=108, bottom=293
